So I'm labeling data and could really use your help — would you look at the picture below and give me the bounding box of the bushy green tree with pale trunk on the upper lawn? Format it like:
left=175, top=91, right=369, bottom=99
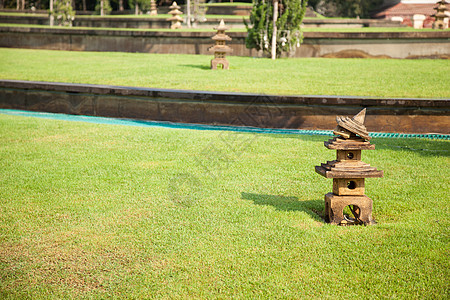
left=244, top=0, right=308, bottom=57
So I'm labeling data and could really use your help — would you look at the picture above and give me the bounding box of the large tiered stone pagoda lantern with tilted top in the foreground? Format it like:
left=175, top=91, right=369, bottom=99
left=316, top=109, right=383, bottom=225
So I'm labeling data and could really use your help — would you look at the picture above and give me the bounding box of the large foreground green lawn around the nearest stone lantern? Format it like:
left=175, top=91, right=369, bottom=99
left=0, top=114, right=450, bottom=299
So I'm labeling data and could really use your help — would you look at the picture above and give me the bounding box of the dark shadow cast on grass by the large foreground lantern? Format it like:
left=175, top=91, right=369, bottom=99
left=241, top=192, right=325, bottom=222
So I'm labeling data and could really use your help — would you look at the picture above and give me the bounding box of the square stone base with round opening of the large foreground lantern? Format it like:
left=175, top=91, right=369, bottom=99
left=325, top=193, right=376, bottom=225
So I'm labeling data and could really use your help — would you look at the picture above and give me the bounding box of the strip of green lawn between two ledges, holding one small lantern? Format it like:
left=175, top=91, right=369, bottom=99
left=0, top=48, right=450, bottom=98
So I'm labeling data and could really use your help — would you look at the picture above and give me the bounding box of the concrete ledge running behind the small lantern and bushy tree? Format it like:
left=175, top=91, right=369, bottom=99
left=0, top=27, right=450, bottom=58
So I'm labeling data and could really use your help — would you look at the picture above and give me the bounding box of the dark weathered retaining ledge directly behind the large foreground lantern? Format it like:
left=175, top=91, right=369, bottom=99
left=0, top=80, right=450, bottom=134
